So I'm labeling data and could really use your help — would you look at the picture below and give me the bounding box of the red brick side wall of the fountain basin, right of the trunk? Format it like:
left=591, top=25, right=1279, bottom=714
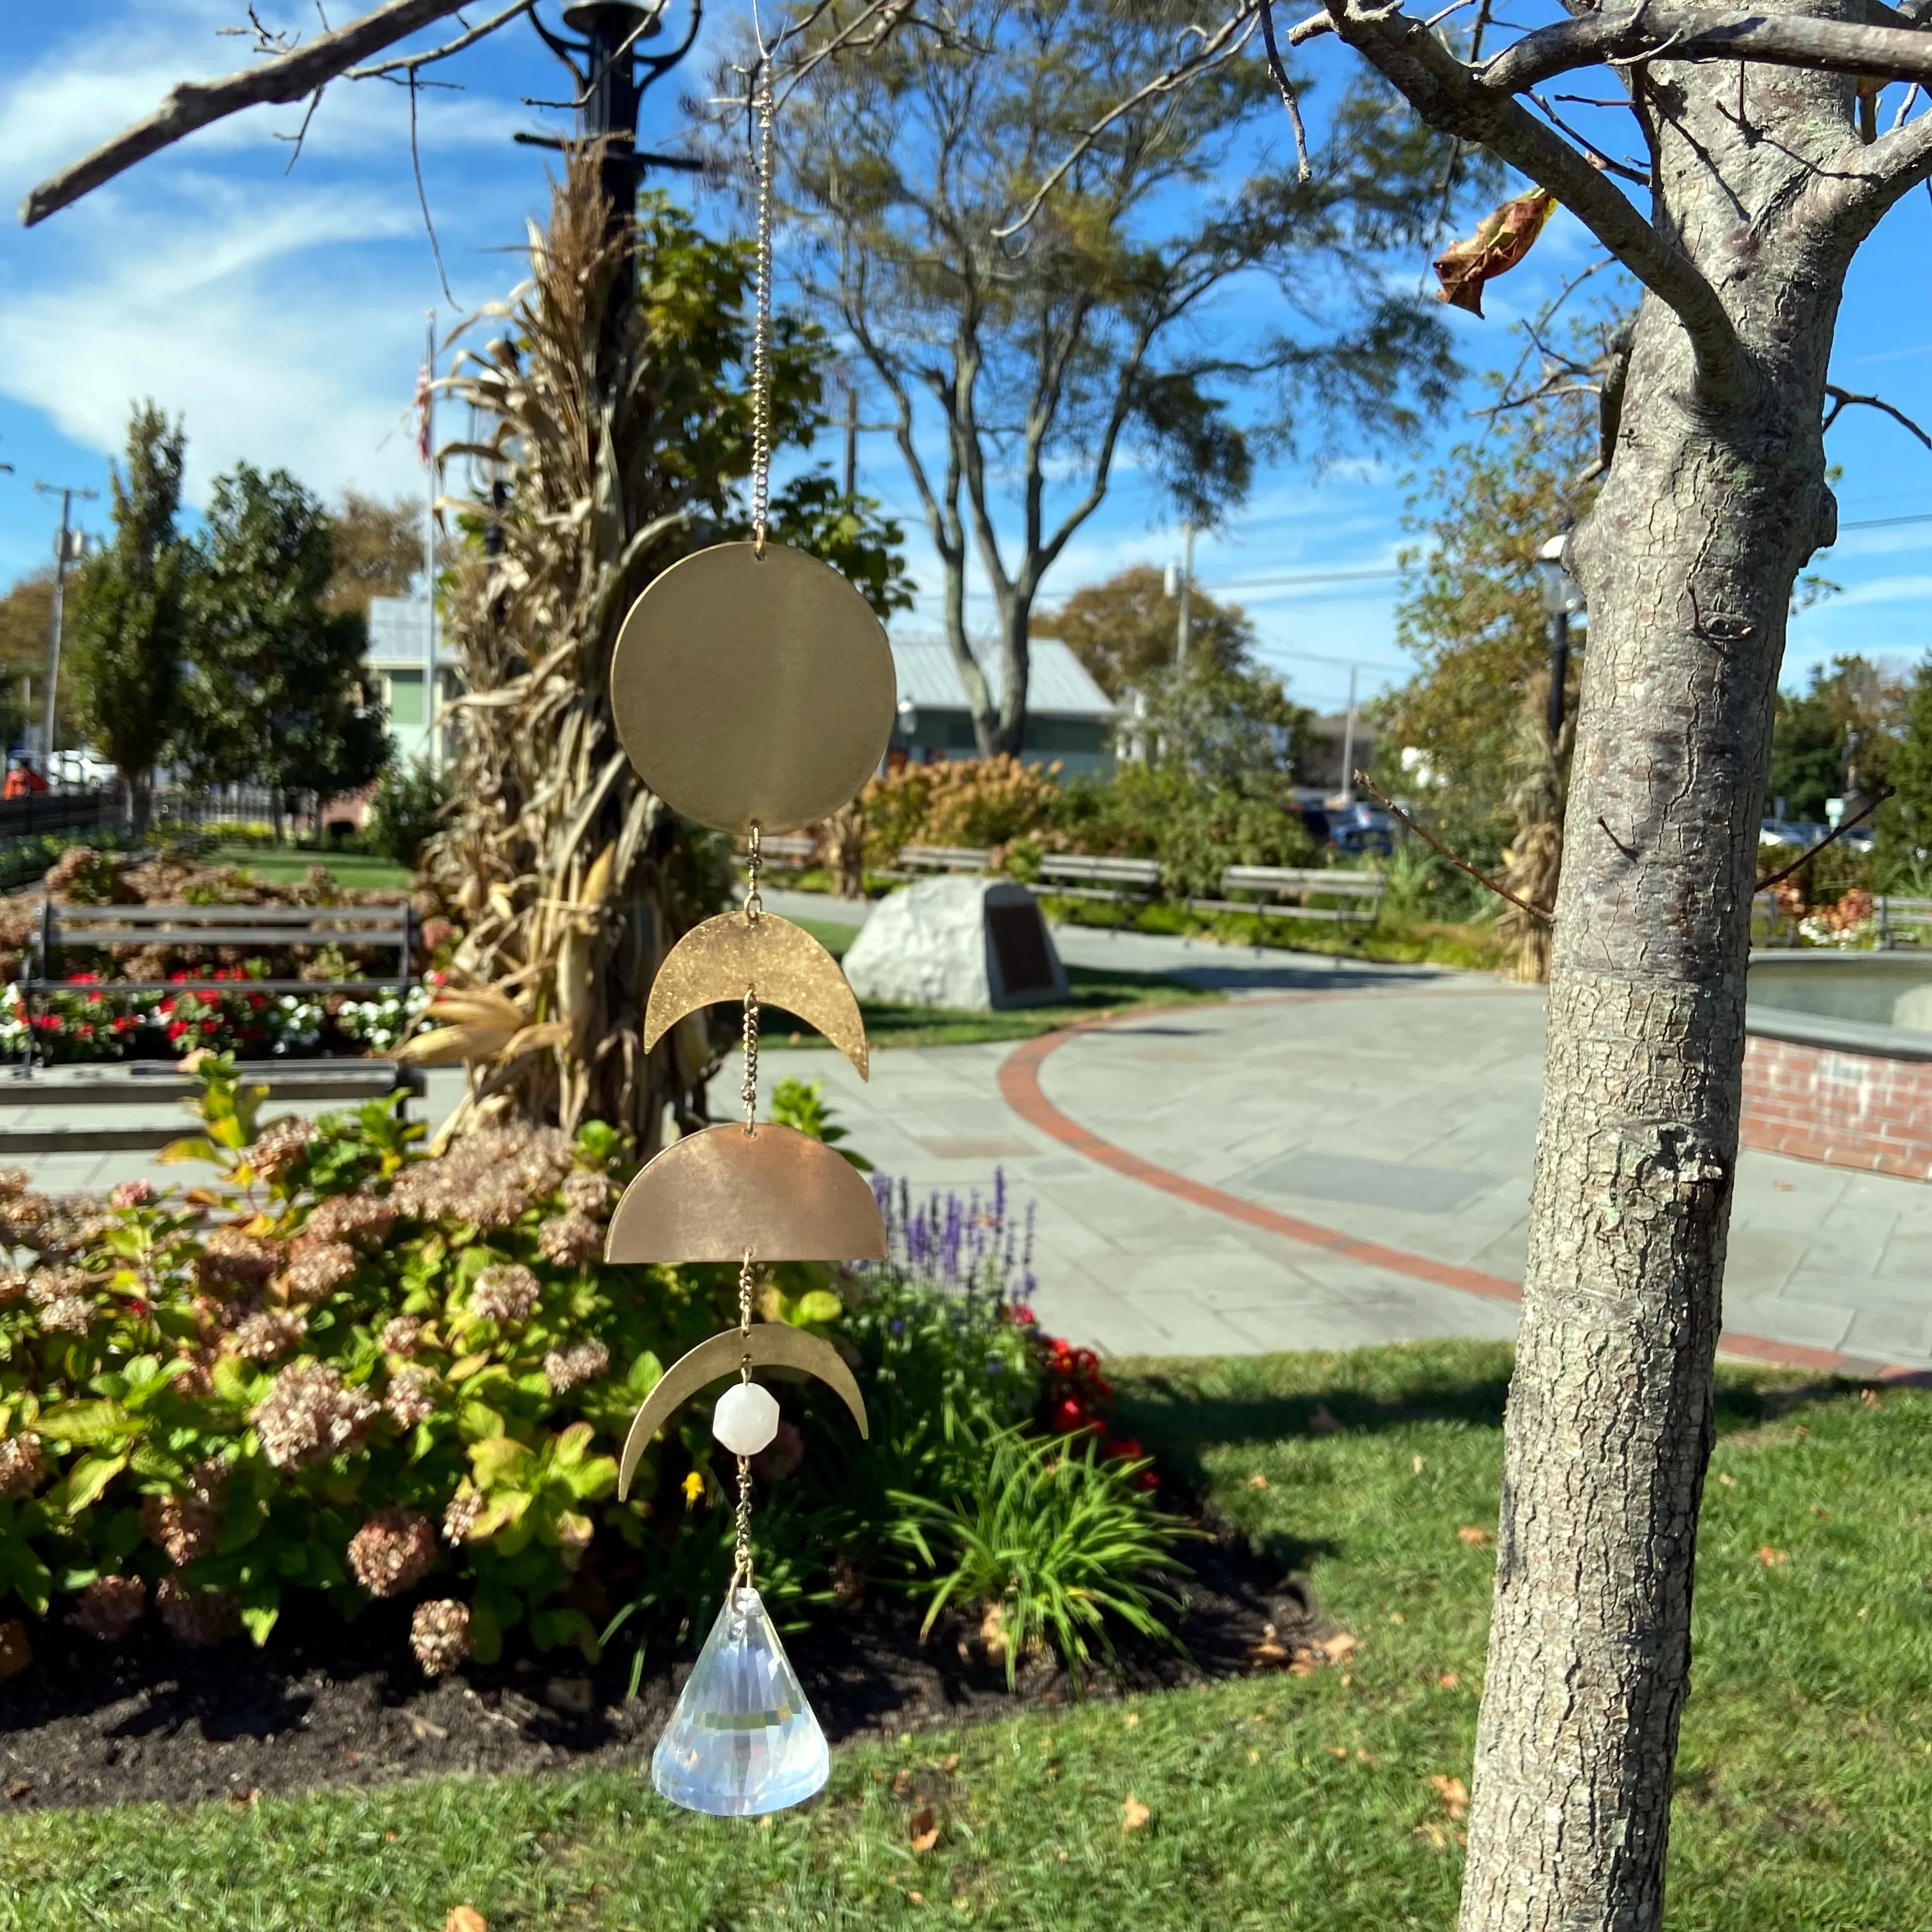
left=1745, top=1034, right=1932, bottom=1181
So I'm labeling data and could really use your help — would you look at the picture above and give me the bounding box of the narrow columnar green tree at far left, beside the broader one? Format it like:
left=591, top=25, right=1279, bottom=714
left=73, top=402, right=193, bottom=832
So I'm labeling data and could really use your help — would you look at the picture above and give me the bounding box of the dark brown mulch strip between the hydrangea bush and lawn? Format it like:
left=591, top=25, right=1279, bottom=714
left=0, top=1538, right=1327, bottom=1816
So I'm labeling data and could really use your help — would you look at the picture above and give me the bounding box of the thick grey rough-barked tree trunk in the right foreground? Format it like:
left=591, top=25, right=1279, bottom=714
left=1460, top=62, right=1855, bottom=1932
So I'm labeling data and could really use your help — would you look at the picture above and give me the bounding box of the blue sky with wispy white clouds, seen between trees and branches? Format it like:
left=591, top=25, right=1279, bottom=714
left=0, top=0, right=1932, bottom=709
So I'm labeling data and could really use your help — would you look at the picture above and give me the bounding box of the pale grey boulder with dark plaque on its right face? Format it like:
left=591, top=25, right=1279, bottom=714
left=840, top=877, right=1066, bottom=1013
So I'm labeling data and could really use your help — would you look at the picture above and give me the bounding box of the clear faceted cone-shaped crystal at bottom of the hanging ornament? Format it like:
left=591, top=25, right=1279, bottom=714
left=651, top=1588, right=831, bottom=1818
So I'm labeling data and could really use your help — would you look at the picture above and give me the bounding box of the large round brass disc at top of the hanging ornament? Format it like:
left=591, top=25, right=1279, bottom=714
left=611, top=543, right=898, bottom=832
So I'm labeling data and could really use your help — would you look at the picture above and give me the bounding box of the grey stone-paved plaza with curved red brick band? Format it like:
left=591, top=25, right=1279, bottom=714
left=7, top=893, right=1932, bottom=1370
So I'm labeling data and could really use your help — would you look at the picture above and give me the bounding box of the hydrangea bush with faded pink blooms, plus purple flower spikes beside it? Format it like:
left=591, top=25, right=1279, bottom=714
left=0, top=1057, right=1174, bottom=1673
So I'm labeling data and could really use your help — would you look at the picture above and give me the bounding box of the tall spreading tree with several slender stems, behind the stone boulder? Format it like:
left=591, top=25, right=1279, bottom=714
left=781, top=0, right=1483, bottom=753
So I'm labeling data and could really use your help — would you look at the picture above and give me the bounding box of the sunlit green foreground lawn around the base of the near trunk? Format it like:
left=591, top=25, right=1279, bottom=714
left=0, top=1345, right=1932, bottom=1932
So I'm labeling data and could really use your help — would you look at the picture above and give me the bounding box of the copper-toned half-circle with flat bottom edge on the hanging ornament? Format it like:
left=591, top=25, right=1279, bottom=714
left=605, top=1121, right=885, bottom=1262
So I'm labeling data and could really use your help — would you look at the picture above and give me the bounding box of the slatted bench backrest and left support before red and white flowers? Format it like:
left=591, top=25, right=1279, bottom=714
left=17, top=898, right=415, bottom=1070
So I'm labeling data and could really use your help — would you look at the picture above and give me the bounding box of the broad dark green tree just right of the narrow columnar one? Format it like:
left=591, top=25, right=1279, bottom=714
left=183, top=464, right=388, bottom=825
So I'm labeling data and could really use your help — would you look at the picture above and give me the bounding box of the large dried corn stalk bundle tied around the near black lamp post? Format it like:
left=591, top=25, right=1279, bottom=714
left=404, top=151, right=746, bottom=1155
